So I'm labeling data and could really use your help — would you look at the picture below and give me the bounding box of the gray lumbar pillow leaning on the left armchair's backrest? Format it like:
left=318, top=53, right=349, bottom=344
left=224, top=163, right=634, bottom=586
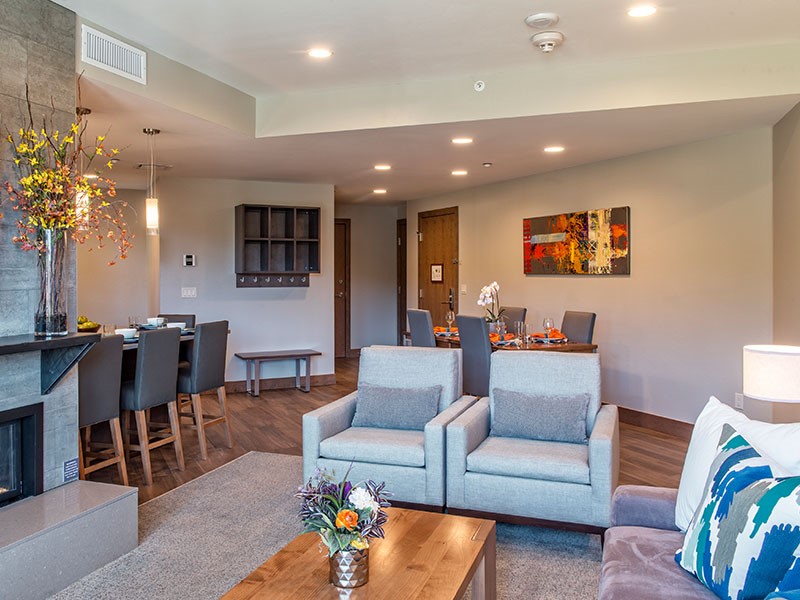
left=353, top=383, right=442, bottom=431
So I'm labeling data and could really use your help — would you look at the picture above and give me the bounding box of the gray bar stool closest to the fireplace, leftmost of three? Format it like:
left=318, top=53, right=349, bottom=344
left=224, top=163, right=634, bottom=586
left=78, top=335, right=128, bottom=485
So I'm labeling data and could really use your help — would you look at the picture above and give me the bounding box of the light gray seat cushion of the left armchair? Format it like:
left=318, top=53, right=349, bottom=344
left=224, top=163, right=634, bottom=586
left=319, top=427, right=425, bottom=467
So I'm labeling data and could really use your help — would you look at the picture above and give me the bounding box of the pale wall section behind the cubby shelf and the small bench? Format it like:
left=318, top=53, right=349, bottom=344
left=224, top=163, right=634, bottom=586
left=158, top=177, right=334, bottom=381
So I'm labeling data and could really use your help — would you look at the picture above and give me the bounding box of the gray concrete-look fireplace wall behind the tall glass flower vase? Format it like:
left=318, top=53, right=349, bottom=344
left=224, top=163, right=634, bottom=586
left=0, top=0, right=78, bottom=489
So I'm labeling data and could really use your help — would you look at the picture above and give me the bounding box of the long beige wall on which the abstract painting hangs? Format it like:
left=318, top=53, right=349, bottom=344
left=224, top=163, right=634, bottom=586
left=408, top=128, right=772, bottom=422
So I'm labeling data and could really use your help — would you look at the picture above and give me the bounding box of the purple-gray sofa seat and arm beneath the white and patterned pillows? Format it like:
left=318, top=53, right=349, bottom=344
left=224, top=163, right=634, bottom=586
left=597, top=485, right=717, bottom=600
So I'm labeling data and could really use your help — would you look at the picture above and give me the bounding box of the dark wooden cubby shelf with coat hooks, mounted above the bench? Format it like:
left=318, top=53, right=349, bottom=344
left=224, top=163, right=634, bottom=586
left=235, top=204, right=320, bottom=287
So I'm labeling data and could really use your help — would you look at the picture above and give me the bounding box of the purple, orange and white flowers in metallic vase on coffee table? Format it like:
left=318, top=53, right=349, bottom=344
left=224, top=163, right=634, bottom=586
left=295, top=469, right=389, bottom=556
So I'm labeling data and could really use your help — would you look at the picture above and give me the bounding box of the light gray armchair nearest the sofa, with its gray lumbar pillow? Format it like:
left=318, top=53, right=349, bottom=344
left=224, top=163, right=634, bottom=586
left=447, top=351, right=619, bottom=527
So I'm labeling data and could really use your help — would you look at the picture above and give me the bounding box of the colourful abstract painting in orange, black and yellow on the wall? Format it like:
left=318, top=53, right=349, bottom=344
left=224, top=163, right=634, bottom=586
left=522, top=206, right=631, bottom=275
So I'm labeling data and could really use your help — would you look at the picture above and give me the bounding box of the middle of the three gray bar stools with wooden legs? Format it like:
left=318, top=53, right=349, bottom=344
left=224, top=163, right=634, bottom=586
left=120, top=328, right=185, bottom=485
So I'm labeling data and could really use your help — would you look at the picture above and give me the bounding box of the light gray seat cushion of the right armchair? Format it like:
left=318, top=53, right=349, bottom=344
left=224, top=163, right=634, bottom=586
left=467, top=436, right=589, bottom=484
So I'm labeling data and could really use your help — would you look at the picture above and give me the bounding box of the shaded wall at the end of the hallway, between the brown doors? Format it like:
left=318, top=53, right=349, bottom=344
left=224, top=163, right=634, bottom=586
left=336, top=204, right=398, bottom=348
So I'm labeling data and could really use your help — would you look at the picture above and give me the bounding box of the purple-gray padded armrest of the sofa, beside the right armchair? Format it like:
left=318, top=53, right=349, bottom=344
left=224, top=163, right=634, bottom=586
left=611, top=485, right=678, bottom=531
